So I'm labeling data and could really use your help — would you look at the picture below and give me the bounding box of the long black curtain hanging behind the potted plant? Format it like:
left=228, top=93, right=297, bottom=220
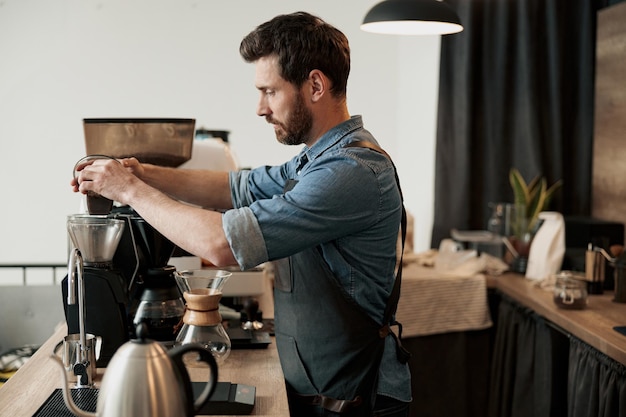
left=432, top=0, right=619, bottom=247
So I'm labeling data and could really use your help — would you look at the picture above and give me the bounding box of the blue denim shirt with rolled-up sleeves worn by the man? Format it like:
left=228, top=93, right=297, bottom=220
left=223, top=116, right=411, bottom=401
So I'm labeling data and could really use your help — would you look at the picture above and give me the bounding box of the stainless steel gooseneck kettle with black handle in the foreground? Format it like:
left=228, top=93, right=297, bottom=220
left=51, top=324, right=217, bottom=417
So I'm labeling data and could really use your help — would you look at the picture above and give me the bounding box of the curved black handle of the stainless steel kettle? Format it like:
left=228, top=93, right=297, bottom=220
left=168, top=343, right=217, bottom=416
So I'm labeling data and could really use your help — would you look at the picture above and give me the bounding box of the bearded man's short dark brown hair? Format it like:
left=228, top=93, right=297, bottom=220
left=239, top=12, right=350, bottom=97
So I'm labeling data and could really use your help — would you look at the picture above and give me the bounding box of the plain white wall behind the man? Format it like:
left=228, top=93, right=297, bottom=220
left=0, top=0, right=440, bottom=281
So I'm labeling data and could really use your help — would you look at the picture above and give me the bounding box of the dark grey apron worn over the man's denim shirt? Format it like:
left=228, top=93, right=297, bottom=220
left=274, top=248, right=385, bottom=416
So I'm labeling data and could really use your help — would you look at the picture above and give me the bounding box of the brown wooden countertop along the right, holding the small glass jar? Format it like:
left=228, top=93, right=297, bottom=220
left=488, top=273, right=626, bottom=365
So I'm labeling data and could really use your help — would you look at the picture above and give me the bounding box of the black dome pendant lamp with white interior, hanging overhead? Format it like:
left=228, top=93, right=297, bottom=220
left=361, top=0, right=463, bottom=35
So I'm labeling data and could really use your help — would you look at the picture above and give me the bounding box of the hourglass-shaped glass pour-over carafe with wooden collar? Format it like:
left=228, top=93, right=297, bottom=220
left=174, top=269, right=232, bottom=363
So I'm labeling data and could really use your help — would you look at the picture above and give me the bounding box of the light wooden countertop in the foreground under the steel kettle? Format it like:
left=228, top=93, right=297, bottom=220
left=0, top=324, right=289, bottom=417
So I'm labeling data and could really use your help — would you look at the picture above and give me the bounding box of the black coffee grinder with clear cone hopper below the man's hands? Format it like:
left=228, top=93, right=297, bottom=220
left=61, top=214, right=128, bottom=367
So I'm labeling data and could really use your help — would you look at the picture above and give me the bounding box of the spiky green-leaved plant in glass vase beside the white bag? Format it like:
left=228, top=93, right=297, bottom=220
left=509, top=168, right=563, bottom=272
